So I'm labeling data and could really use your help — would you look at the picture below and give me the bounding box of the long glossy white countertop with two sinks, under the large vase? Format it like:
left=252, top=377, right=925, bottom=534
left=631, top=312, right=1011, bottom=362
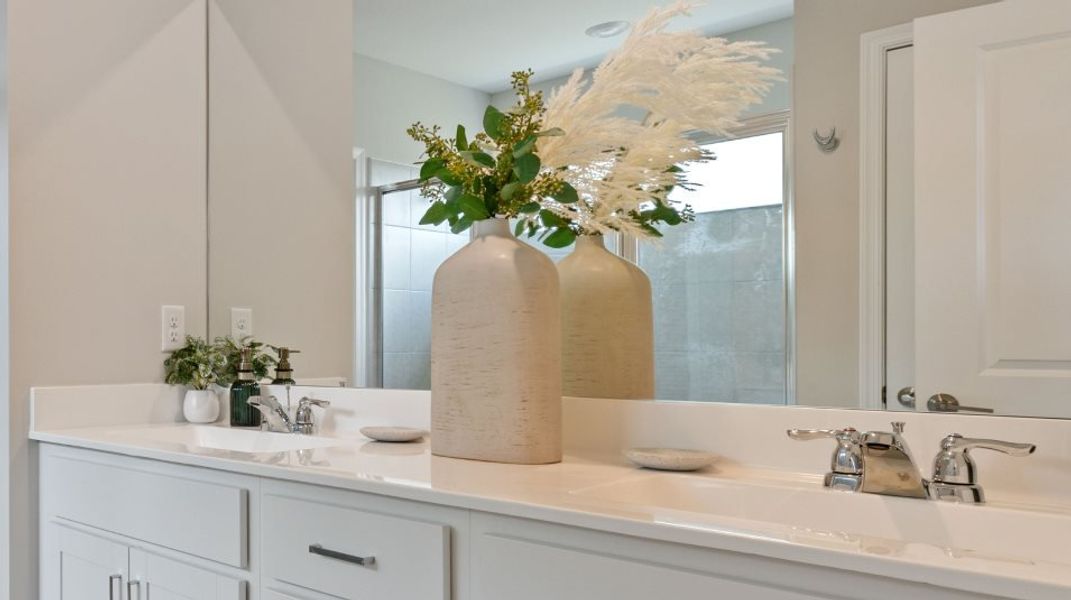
left=30, top=424, right=1071, bottom=599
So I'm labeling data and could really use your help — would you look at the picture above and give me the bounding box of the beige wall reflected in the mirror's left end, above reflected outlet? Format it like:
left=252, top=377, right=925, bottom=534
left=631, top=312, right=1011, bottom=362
left=209, top=0, right=355, bottom=380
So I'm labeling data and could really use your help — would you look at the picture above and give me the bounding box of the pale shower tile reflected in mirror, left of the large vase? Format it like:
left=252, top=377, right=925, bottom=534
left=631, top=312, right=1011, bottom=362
left=369, top=160, right=469, bottom=390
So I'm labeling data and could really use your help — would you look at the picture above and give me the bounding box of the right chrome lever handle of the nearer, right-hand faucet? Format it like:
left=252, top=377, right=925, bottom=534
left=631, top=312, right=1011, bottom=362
left=930, top=433, right=1038, bottom=503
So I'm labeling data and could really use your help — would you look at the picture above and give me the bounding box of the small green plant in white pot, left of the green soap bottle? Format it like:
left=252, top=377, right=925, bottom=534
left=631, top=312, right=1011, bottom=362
left=164, top=335, right=226, bottom=423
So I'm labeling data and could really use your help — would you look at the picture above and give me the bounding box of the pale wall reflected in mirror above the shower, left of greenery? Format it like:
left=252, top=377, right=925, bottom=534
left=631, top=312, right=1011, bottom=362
left=352, top=55, right=491, bottom=164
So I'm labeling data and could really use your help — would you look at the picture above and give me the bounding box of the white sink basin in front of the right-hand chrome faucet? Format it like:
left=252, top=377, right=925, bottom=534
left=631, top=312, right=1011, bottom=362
left=573, top=474, right=1071, bottom=568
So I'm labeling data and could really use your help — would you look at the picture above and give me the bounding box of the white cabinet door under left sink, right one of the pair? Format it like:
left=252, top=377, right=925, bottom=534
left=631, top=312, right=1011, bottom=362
left=127, top=549, right=245, bottom=600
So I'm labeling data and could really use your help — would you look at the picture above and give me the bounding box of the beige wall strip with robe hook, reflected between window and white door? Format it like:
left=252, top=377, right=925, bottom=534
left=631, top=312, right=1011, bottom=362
left=793, top=0, right=991, bottom=406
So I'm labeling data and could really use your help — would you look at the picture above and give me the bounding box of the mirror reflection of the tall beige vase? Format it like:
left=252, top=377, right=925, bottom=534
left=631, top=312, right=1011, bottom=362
left=558, top=236, right=654, bottom=399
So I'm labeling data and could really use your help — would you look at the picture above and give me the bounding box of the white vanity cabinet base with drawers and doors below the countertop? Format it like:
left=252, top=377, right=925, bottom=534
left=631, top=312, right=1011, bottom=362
left=40, top=444, right=1019, bottom=600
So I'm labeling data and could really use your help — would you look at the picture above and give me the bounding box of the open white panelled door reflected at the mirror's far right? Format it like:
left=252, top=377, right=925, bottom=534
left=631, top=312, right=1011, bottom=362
left=915, top=0, right=1071, bottom=417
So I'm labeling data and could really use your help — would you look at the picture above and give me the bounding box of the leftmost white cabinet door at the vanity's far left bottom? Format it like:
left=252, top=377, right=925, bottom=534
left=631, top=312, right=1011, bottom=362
left=48, top=524, right=127, bottom=600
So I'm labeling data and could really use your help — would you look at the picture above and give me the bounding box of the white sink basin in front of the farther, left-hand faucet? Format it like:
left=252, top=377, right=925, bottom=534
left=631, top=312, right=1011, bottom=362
left=107, top=425, right=347, bottom=453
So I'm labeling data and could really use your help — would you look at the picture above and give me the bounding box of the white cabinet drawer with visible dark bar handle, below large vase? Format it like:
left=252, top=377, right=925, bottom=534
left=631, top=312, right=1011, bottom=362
left=261, top=495, right=450, bottom=600
